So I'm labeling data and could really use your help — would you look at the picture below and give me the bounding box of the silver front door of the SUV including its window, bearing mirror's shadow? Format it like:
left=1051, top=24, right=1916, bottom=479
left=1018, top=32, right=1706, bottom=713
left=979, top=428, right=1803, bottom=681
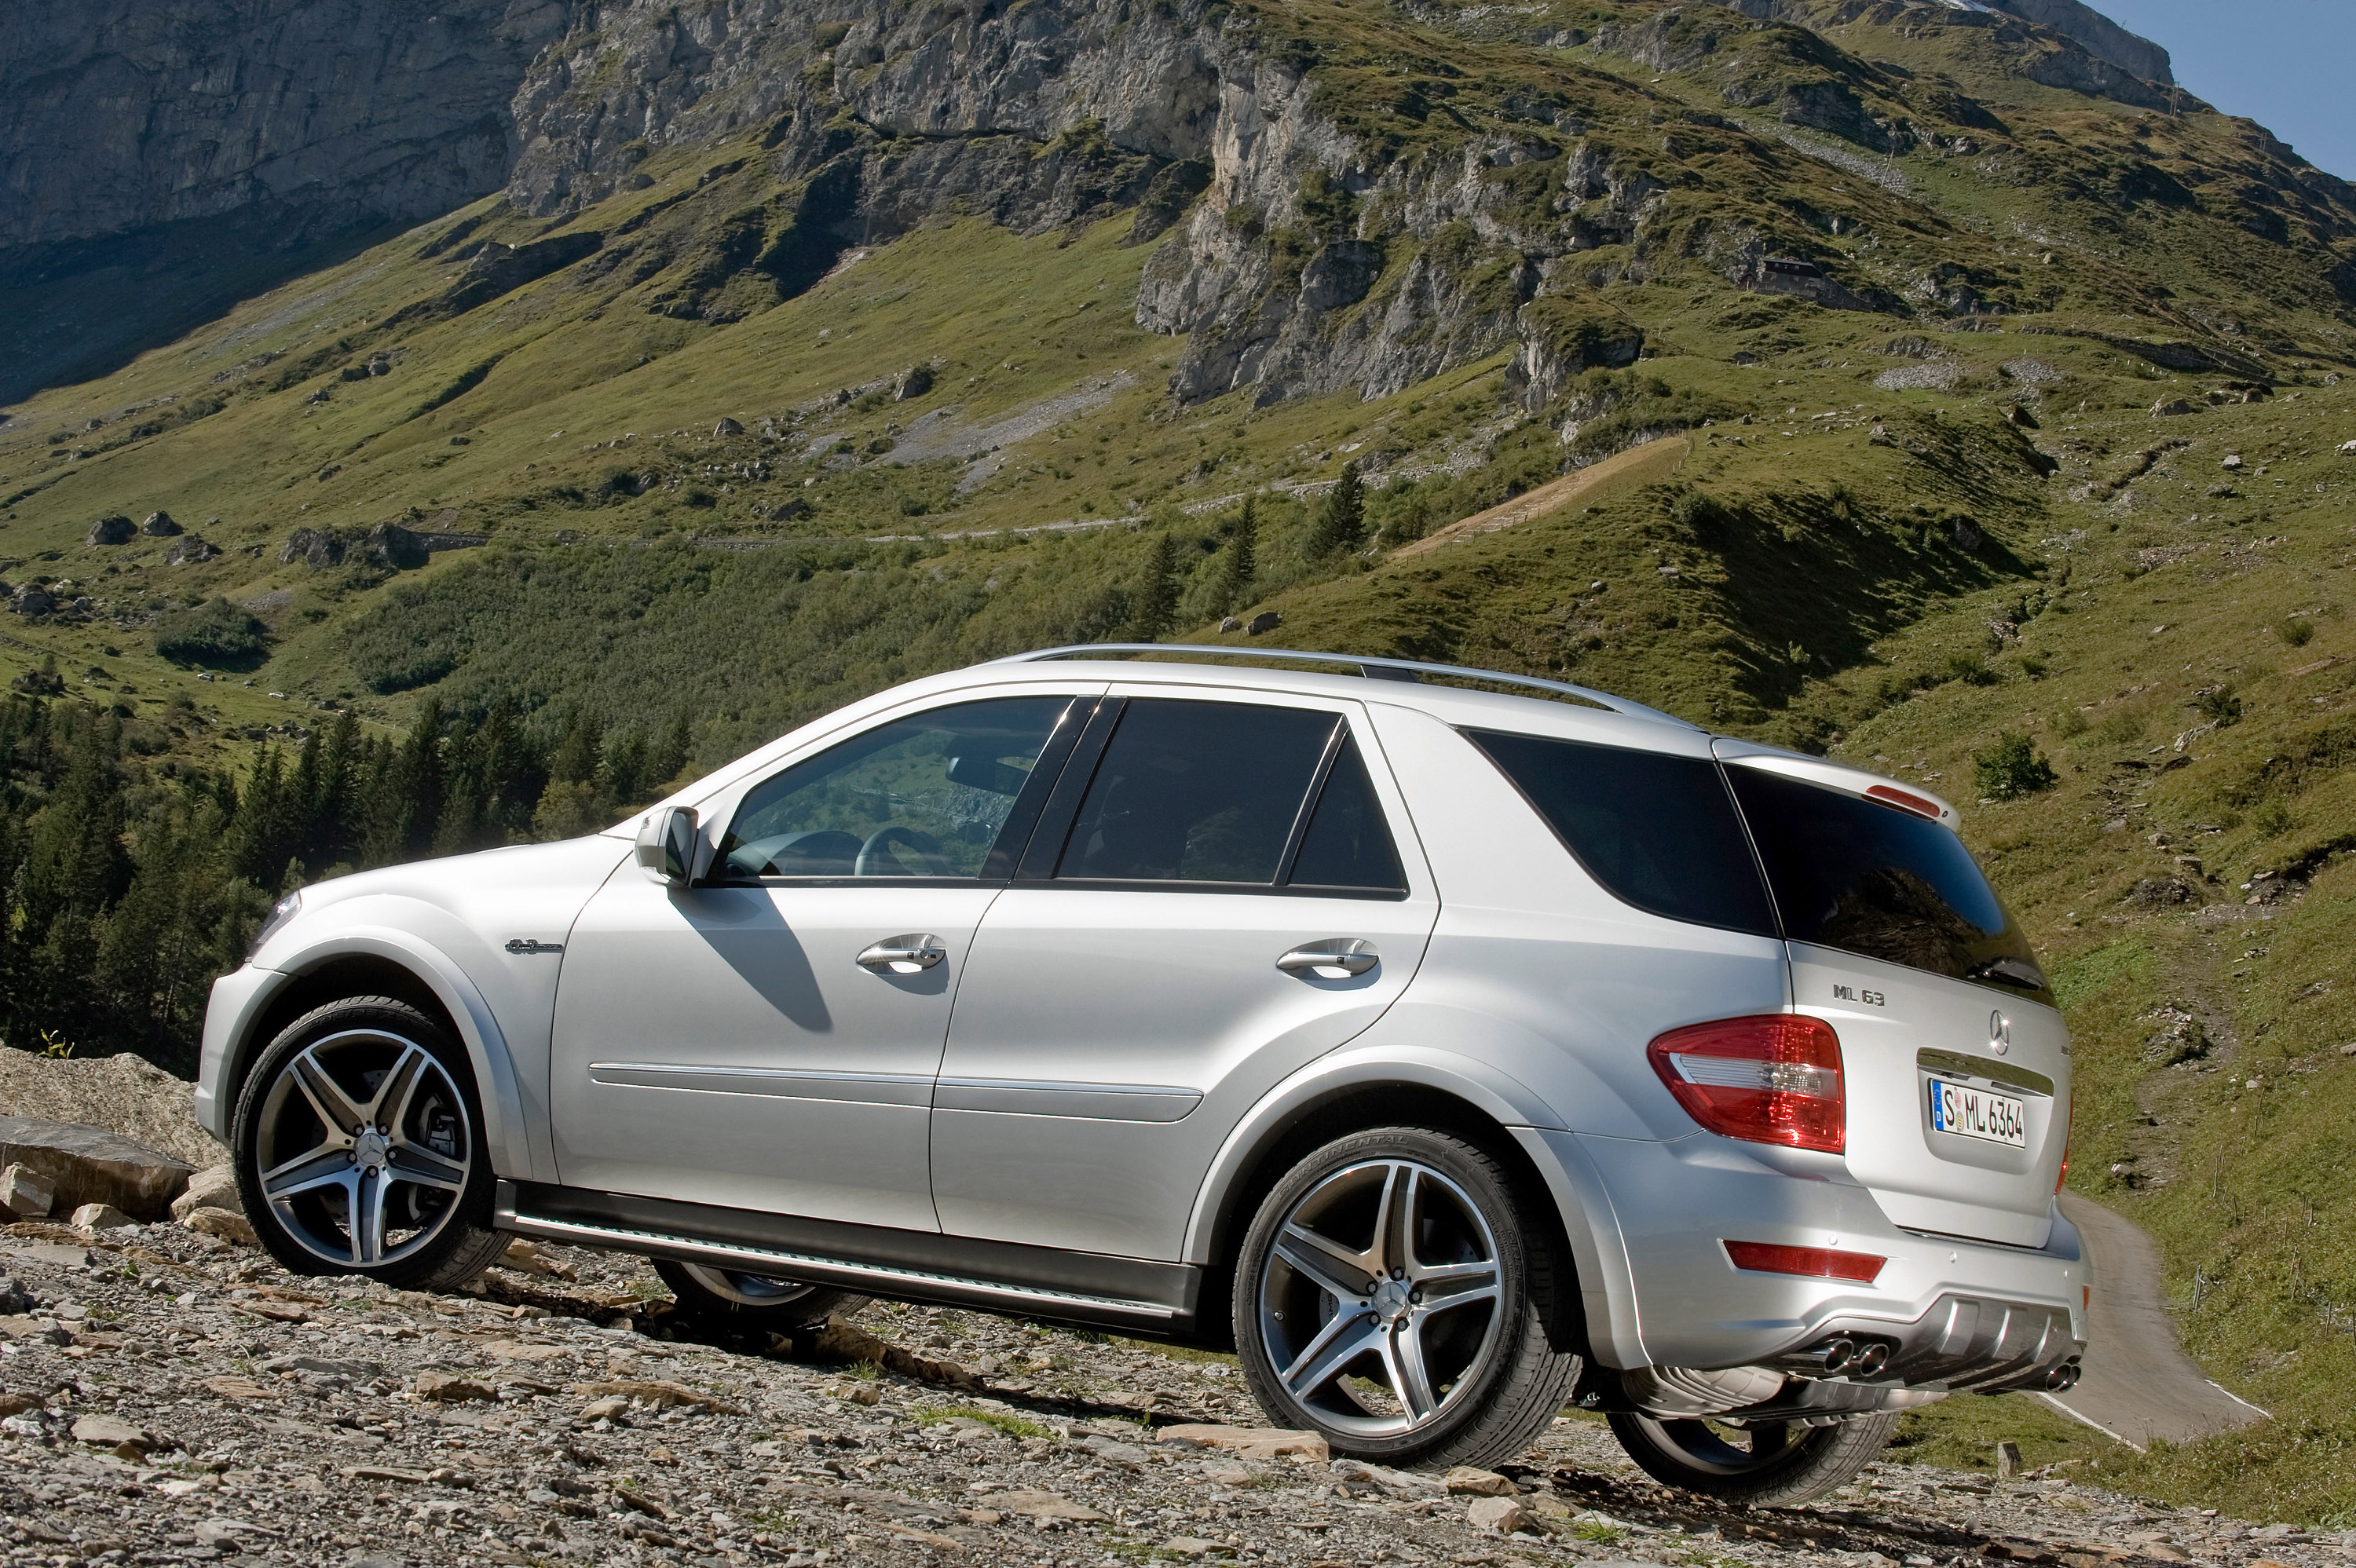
left=551, top=697, right=1072, bottom=1231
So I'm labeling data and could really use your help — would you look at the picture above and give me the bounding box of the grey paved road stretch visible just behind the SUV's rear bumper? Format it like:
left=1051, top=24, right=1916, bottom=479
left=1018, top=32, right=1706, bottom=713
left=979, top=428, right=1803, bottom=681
left=2045, top=1191, right=2266, bottom=1448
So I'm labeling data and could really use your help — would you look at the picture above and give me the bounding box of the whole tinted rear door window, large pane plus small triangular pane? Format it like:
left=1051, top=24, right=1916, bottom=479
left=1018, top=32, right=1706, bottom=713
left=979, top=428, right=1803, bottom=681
left=1055, top=700, right=1404, bottom=887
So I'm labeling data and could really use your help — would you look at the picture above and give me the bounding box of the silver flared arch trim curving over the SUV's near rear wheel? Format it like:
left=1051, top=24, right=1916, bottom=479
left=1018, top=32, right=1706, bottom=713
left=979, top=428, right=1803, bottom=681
left=1183, top=1036, right=1644, bottom=1365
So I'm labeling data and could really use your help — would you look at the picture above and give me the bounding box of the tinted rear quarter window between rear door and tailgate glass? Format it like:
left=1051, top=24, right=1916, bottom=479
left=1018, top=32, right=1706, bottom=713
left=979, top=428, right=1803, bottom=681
left=1468, top=730, right=1774, bottom=937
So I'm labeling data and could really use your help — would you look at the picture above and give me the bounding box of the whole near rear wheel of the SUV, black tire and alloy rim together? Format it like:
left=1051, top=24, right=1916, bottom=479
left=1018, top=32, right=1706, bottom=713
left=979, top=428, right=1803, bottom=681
left=1235, top=1128, right=1579, bottom=1467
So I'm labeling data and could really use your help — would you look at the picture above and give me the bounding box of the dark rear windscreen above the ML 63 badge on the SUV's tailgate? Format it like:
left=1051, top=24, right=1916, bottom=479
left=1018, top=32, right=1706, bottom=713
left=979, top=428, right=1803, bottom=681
left=1727, top=768, right=2050, bottom=1000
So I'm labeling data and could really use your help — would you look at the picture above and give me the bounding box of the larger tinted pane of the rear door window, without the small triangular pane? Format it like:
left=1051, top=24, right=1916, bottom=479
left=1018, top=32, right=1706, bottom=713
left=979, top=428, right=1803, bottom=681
left=1055, top=702, right=1336, bottom=883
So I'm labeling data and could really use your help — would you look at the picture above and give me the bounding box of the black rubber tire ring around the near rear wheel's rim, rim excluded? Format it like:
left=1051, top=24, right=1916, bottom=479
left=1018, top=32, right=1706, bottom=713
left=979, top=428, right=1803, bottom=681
left=1232, top=1128, right=1538, bottom=1464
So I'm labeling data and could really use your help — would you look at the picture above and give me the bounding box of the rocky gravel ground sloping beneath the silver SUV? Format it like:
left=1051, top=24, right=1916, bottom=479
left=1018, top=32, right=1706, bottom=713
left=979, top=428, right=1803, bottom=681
left=0, top=1224, right=2356, bottom=1568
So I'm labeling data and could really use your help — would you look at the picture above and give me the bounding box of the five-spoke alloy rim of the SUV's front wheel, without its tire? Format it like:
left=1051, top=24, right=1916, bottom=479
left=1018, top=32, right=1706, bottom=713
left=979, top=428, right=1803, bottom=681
left=257, top=1029, right=476, bottom=1269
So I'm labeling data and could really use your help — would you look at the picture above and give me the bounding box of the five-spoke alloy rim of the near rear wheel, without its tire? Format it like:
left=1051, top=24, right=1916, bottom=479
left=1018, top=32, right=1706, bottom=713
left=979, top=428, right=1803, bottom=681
left=1258, top=1158, right=1503, bottom=1438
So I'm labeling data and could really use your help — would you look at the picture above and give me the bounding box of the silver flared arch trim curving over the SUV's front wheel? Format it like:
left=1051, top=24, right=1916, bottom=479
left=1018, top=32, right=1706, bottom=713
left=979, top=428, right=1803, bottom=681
left=221, top=932, right=532, bottom=1177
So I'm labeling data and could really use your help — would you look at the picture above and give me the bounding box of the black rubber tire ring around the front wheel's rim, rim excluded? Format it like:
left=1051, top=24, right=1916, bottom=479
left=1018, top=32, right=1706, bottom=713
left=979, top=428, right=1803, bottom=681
left=231, top=996, right=497, bottom=1285
